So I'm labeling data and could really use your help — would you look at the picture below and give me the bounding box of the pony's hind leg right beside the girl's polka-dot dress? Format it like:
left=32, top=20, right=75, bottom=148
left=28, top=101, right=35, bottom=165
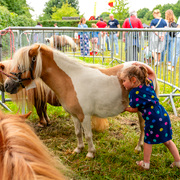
left=135, top=112, right=144, bottom=152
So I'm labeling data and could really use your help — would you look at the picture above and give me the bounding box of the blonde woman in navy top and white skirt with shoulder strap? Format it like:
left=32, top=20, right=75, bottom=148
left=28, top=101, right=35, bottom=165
left=149, top=9, right=167, bottom=66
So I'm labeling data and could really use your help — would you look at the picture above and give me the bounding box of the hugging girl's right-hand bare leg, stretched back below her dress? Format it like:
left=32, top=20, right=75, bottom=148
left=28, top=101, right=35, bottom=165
left=164, top=140, right=180, bottom=162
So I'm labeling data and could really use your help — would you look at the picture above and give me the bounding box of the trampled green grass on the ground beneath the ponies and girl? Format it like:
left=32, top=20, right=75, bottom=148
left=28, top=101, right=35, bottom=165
left=0, top=44, right=180, bottom=180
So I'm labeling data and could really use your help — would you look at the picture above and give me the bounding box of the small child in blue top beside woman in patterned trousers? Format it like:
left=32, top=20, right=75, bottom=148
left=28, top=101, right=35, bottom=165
left=90, top=23, right=99, bottom=55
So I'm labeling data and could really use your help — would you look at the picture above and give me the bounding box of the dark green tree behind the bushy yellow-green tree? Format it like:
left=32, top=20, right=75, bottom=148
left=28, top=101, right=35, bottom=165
left=43, top=0, right=79, bottom=17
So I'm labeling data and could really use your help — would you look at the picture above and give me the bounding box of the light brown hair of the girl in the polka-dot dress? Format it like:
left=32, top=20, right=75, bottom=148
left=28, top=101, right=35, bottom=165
left=121, top=65, right=150, bottom=85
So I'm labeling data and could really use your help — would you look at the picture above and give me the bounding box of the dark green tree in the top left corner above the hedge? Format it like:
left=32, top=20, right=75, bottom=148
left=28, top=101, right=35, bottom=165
left=0, top=0, right=32, bottom=18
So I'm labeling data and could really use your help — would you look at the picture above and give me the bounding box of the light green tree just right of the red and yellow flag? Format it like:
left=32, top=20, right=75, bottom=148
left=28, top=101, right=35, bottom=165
left=114, top=0, right=129, bottom=20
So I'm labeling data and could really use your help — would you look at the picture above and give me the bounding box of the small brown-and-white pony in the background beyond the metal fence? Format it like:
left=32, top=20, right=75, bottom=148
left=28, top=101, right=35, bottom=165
left=50, top=35, right=77, bottom=52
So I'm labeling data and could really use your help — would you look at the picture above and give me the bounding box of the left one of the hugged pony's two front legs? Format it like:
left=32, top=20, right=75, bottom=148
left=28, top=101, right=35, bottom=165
left=72, top=117, right=84, bottom=153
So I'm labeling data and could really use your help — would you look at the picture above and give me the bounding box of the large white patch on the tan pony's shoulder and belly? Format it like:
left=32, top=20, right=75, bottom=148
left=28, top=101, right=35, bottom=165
left=53, top=51, right=124, bottom=117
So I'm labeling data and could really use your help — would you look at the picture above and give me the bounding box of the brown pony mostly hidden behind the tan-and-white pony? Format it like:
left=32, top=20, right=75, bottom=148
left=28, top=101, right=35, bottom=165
left=0, top=60, right=109, bottom=131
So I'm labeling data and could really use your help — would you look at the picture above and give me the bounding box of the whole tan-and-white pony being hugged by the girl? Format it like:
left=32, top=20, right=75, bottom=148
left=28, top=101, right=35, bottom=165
left=5, top=44, right=157, bottom=158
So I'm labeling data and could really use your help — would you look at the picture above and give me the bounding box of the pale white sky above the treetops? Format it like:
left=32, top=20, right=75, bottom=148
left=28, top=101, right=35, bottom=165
left=26, top=0, right=178, bottom=19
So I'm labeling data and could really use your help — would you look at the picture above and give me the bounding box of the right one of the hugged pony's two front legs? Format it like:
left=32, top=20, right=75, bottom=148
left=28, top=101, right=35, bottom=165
left=82, top=116, right=96, bottom=158
